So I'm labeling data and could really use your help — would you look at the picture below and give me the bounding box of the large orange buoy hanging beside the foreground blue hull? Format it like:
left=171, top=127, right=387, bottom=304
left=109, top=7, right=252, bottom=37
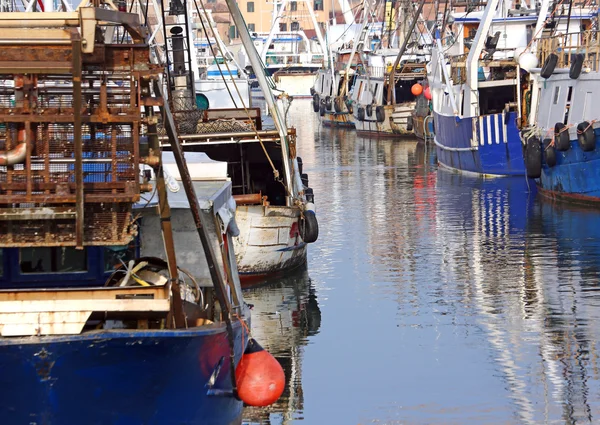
left=235, top=338, right=285, bottom=406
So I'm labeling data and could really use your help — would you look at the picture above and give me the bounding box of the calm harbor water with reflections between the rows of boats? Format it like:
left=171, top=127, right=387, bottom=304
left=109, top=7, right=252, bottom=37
left=244, top=100, right=600, bottom=425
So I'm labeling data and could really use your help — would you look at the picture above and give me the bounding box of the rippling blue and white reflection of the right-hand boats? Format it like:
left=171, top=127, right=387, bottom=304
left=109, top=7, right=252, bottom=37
left=437, top=170, right=600, bottom=424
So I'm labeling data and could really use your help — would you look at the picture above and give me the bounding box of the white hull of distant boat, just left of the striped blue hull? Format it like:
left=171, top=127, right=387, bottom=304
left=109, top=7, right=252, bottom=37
left=354, top=102, right=416, bottom=137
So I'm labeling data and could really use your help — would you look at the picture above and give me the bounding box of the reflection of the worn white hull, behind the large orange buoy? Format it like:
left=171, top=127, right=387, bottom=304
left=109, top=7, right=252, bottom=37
left=244, top=267, right=321, bottom=424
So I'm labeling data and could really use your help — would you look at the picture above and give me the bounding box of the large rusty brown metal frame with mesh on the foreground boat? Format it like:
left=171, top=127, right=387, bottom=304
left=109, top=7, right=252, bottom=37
left=0, top=7, right=162, bottom=248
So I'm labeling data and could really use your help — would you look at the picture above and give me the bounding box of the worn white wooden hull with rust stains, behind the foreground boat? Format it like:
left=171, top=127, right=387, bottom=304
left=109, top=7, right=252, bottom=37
left=234, top=205, right=306, bottom=278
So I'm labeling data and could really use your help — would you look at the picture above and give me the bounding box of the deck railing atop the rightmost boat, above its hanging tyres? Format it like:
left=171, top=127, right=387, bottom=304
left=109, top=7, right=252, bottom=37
left=538, top=31, right=600, bottom=71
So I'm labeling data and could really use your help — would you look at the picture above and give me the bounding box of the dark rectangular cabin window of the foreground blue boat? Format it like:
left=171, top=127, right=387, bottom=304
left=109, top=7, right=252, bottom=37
left=19, top=247, right=87, bottom=274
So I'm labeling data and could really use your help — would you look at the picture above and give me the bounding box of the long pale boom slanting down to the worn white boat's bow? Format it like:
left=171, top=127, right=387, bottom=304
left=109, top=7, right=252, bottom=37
left=225, top=0, right=297, bottom=206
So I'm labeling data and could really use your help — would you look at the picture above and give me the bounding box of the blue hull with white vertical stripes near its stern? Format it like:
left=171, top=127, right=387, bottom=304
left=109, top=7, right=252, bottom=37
left=434, top=112, right=525, bottom=176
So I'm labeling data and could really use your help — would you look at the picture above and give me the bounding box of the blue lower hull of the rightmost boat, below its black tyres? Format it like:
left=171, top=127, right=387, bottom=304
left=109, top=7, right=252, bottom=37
left=538, top=129, right=600, bottom=203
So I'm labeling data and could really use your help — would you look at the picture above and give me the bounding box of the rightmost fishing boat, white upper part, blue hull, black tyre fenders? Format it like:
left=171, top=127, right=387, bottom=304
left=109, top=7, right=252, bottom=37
left=522, top=22, right=600, bottom=204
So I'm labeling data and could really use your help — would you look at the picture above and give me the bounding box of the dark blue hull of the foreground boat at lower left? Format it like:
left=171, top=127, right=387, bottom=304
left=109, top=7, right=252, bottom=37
left=0, top=322, right=247, bottom=425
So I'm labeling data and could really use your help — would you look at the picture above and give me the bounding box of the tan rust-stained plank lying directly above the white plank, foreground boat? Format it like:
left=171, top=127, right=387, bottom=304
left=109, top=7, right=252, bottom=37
left=0, top=286, right=168, bottom=302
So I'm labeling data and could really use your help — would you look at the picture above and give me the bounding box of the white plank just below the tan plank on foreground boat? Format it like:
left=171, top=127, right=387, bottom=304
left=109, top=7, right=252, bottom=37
left=0, top=298, right=170, bottom=313
